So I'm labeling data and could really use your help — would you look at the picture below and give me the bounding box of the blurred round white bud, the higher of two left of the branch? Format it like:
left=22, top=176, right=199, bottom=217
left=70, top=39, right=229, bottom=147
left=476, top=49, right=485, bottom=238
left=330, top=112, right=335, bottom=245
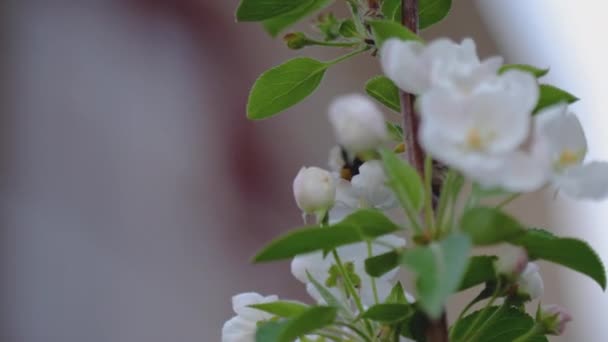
left=329, top=94, right=388, bottom=155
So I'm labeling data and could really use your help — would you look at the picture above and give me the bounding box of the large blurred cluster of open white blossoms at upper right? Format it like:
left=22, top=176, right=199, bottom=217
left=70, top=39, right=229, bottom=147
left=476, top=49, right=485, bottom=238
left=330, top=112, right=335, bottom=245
left=381, top=39, right=608, bottom=199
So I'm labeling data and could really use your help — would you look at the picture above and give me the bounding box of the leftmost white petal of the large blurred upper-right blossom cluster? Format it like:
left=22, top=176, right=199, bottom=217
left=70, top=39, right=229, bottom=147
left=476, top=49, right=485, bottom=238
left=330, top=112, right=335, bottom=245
left=380, top=39, right=431, bottom=94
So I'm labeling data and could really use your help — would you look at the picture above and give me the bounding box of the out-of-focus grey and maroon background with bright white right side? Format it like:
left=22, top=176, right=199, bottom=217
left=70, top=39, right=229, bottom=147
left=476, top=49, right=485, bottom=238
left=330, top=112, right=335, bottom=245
left=0, top=0, right=608, bottom=342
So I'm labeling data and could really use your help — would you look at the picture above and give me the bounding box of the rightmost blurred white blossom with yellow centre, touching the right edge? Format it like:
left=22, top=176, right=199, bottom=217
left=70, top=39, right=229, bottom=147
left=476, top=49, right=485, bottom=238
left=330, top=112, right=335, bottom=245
left=537, top=105, right=608, bottom=200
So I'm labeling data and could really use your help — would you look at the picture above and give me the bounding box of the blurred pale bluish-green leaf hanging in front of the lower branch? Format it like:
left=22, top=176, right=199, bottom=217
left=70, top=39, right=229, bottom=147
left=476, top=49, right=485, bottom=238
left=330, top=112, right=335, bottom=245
left=402, top=234, right=471, bottom=319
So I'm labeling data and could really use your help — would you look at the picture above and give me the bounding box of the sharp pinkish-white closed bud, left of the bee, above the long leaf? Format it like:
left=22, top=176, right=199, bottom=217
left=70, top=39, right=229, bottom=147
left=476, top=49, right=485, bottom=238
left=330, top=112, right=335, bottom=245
left=293, top=167, right=336, bottom=214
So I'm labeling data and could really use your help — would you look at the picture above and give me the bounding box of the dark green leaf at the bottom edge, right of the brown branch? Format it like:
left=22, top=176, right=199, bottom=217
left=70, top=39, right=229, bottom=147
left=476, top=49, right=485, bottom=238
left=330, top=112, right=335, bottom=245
left=452, top=306, right=547, bottom=342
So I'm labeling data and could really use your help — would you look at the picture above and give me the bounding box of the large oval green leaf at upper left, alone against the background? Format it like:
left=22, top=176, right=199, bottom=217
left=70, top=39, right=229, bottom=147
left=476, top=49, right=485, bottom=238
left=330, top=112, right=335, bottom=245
left=247, top=57, right=328, bottom=120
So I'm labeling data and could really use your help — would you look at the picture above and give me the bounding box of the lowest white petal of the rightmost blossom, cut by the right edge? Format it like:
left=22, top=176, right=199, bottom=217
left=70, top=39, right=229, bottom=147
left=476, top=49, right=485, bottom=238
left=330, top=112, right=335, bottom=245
left=556, top=161, right=608, bottom=200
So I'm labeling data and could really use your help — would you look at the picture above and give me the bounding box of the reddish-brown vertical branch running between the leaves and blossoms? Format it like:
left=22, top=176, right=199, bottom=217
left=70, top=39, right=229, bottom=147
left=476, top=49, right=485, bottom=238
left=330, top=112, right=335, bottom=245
left=401, top=0, right=449, bottom=342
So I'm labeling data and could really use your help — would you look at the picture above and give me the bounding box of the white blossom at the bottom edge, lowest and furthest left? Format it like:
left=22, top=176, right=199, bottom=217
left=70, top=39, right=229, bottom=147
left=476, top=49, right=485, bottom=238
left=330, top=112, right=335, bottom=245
left=222, top=292, right=279, bottom=342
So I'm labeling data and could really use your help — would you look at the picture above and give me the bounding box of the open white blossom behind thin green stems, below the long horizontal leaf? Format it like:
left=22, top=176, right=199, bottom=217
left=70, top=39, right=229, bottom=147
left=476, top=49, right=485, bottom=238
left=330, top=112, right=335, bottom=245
left=291, top=235, right=405, bottom=306
